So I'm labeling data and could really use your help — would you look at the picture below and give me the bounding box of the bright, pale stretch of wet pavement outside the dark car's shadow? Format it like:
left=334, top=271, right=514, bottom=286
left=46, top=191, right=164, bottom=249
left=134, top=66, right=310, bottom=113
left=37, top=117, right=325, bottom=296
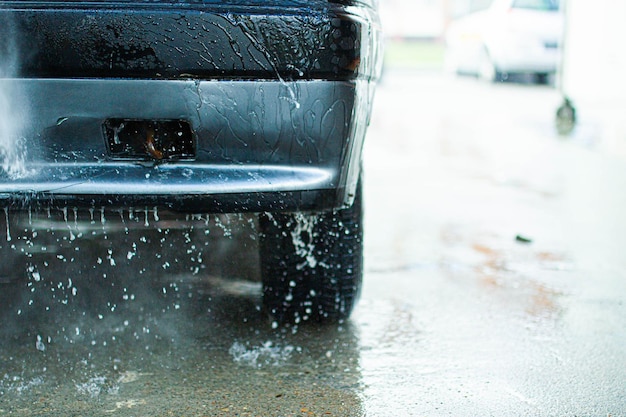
left=356, top=71, right=626, bottom=416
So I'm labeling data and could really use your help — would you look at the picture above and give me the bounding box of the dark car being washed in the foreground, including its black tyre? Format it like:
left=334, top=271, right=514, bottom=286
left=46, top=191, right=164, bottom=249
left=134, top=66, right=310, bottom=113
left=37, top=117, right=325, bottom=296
left=0, top=0, right=381, bottom=321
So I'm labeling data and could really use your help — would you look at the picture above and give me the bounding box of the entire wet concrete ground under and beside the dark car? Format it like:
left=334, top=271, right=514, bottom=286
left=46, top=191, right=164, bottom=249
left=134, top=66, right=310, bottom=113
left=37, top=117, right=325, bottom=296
left=0, top=71, right=626, bottom=417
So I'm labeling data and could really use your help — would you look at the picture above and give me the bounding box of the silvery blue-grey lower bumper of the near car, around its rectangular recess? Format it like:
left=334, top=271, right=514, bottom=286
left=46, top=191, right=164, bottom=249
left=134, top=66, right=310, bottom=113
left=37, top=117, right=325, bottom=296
left=0, top=79, right=370, bottom=211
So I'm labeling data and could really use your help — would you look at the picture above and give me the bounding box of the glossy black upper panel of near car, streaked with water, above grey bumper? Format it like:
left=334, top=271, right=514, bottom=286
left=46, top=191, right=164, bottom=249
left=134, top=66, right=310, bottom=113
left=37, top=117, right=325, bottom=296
left=0, top=1, right=374, bottom=80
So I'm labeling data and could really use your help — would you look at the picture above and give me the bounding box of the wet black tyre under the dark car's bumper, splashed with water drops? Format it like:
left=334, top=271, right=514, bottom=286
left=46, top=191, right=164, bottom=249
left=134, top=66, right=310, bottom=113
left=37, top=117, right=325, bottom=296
left=259, top=184, right=363, bottom=323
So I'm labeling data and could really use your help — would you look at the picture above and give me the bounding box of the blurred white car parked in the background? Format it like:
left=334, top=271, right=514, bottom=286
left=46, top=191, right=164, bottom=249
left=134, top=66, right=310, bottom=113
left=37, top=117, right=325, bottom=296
left=446, top=0, right=563, bottom=83
